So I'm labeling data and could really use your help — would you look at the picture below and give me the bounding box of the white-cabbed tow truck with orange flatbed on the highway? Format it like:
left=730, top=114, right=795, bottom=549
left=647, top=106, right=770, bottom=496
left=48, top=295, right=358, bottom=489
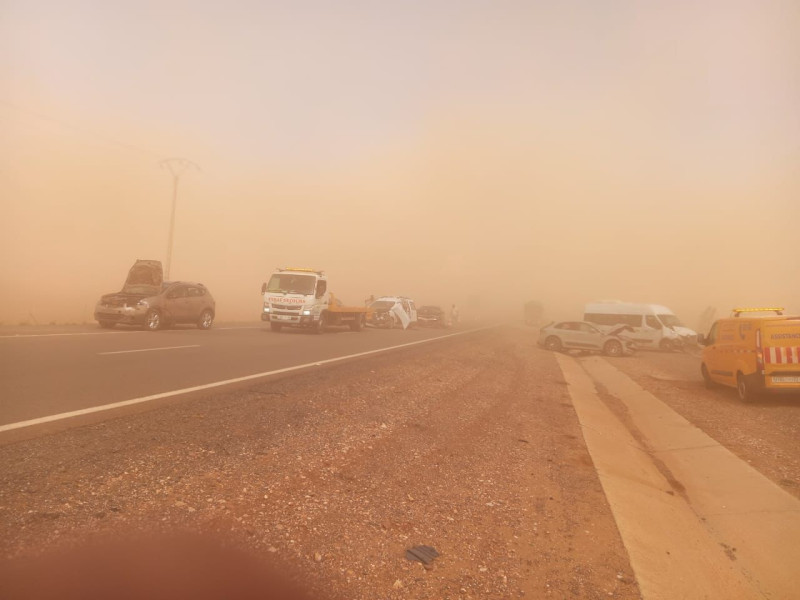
left=261, top=267, right=371, bottom=333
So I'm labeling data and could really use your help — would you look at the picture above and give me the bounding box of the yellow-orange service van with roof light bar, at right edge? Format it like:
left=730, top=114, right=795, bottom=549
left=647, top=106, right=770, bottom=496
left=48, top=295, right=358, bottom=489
left=697, top=308, right=800, bottom=402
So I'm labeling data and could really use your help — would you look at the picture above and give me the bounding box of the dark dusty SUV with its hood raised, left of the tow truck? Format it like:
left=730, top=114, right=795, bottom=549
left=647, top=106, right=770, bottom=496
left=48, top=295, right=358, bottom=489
left=94, top=260, right=215, bottom=331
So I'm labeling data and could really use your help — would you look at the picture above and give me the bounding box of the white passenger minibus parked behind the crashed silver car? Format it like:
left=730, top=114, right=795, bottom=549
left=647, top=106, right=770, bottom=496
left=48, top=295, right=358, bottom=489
left=583, top=302, right=697, bottom=350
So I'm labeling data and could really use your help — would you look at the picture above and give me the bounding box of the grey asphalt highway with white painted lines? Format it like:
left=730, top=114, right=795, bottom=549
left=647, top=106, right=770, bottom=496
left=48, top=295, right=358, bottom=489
left=0, top=323, right=482, bottom=433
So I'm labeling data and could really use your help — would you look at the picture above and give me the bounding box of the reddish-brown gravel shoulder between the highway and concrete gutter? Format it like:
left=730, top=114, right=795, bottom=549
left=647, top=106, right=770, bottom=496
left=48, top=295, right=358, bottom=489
left=0, top=328, right=636, bottom=599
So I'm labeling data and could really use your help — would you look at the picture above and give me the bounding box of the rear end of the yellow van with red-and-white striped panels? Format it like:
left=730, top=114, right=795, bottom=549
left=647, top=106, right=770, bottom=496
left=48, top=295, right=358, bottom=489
left=761, top=317, right=800, bottom=390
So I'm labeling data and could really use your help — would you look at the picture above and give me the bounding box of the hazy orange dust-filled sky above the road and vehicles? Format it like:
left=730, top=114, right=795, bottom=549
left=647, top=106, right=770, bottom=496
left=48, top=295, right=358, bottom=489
left=0, top=0, right=800, bottom=326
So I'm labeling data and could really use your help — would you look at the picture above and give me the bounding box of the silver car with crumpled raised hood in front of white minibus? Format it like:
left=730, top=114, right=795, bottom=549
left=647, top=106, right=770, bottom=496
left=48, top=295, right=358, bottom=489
left=539, top=321, right=636, bottom=356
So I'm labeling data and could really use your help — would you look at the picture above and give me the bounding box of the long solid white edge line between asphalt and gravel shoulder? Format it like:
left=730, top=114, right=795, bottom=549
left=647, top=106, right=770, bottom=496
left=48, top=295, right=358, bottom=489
left=0, top=325, right=499, bottom=433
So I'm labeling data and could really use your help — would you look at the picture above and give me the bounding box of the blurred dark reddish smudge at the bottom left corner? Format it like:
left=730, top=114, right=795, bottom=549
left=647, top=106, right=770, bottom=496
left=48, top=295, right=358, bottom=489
left=0, top=534, right=330, bottom=600
